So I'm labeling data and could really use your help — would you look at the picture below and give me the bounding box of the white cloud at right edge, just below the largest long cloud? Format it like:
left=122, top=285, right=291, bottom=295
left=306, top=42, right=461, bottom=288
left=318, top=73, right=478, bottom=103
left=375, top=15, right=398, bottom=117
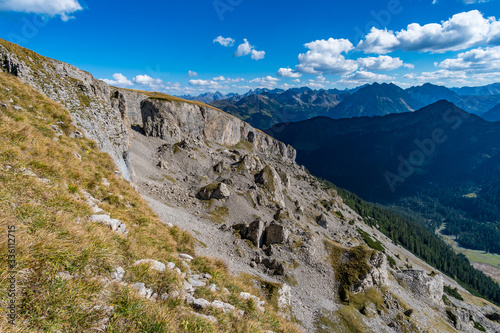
left=438, top=46, right=500, bottom=72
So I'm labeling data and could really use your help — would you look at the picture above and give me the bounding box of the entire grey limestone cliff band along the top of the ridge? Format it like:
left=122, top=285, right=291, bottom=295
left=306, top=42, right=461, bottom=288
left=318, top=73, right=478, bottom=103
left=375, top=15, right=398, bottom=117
left=0, top=39, right=295, bottom=182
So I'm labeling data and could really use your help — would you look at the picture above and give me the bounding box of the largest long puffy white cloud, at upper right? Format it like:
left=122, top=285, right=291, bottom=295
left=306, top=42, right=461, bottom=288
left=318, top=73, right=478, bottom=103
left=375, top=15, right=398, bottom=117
left=357, top=10, right=500, bottom=54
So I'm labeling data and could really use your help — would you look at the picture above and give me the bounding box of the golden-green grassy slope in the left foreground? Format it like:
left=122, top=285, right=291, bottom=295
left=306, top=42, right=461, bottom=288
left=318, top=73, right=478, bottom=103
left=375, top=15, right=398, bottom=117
left=0, top=73, right=296, bottom=332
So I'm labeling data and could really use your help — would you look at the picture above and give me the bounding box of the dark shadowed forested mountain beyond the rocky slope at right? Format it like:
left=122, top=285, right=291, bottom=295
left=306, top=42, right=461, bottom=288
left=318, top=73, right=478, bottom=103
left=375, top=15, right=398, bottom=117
left=266, top=100, right=500, bottom=253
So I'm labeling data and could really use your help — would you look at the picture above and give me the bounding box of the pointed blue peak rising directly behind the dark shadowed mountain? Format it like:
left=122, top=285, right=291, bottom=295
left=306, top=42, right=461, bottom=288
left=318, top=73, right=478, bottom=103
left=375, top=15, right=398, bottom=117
left=333, top=83, right=423, bottom=118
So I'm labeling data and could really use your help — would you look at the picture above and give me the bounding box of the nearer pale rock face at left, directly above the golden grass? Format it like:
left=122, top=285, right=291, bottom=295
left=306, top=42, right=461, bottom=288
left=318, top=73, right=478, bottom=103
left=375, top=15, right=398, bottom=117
left=0, top=41, right=134, bottom=181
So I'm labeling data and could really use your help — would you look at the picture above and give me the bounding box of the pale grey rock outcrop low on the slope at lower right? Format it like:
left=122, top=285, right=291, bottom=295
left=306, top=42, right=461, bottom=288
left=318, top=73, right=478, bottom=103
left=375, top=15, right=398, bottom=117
left=395, top=270, right=444, bottom=305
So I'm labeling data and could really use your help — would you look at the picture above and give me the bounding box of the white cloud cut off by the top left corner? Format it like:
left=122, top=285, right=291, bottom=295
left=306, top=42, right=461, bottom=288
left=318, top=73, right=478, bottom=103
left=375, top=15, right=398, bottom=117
left=0, top=0, right=83, bottom=21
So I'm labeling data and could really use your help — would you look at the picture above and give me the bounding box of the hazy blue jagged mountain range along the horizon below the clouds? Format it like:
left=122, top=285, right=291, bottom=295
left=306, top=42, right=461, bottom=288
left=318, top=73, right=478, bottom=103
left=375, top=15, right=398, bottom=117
left=182, top=83, right=500, bottom=129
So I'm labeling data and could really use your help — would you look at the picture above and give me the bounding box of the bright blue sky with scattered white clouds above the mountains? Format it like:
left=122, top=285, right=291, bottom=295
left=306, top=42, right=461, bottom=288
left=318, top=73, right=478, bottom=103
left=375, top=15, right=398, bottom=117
left=0, top=0, right=500, bottom=95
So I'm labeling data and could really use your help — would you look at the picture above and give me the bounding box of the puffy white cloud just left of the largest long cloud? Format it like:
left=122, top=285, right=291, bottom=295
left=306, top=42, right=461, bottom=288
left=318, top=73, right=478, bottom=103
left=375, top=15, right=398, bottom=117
left=295, top=38, right=358, bottom=74
